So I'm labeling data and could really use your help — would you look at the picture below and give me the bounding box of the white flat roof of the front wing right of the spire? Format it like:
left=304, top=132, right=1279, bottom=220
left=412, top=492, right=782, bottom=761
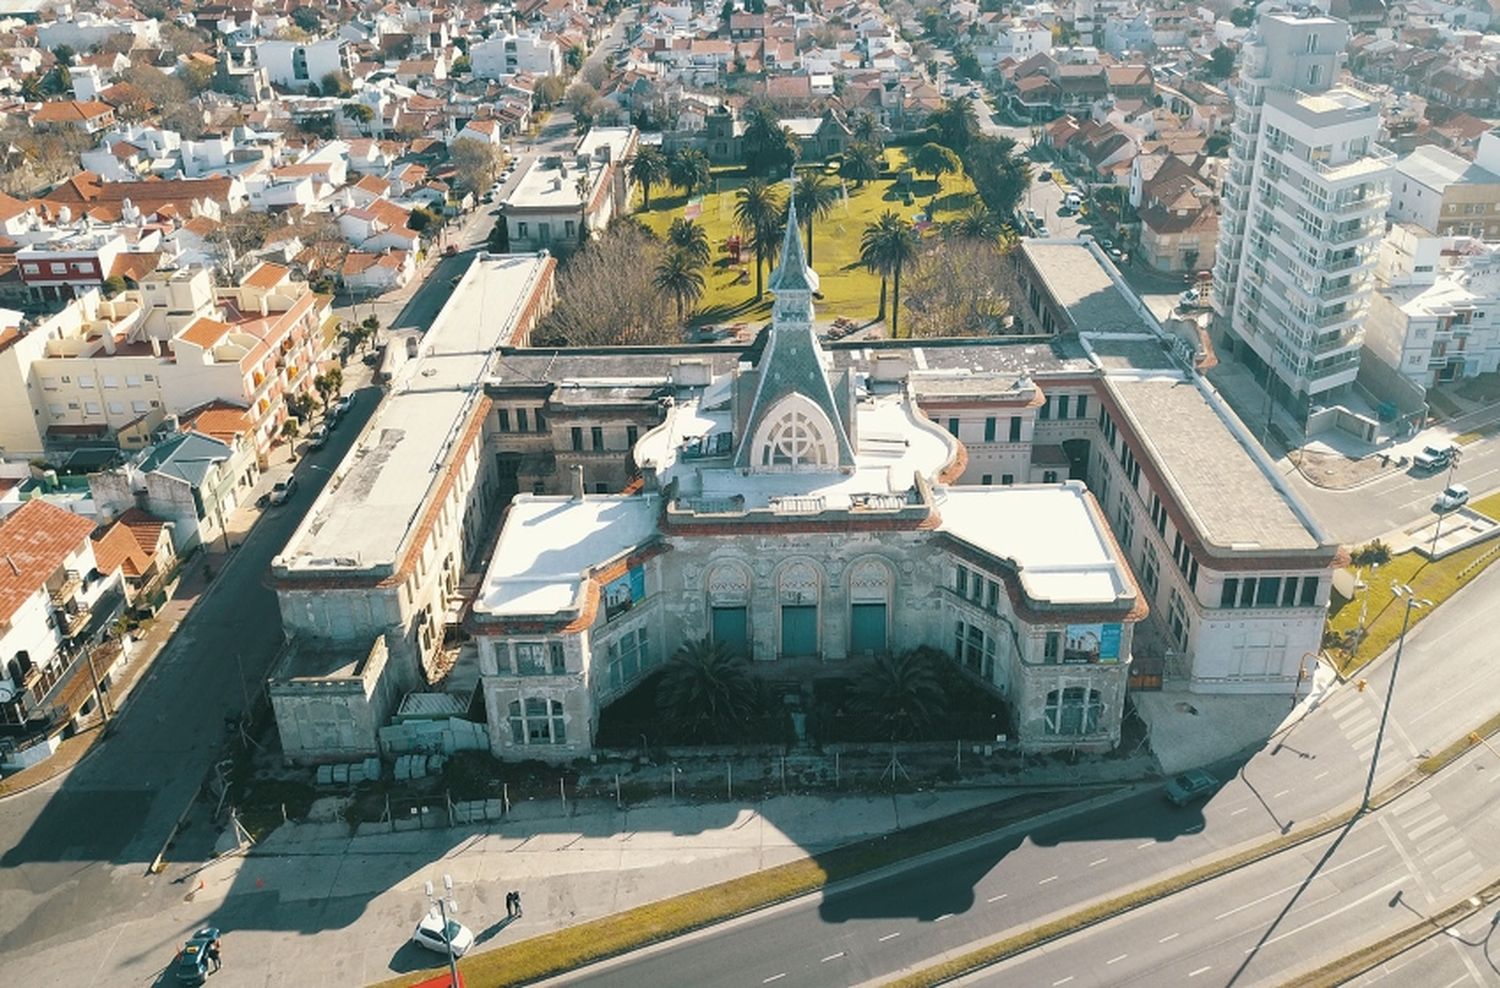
left=938, top=481, right=1133, bottom=604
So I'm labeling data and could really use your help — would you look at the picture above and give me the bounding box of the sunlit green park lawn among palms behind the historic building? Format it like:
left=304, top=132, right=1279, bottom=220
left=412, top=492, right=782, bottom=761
left=636, top=148, right=978, bottom=325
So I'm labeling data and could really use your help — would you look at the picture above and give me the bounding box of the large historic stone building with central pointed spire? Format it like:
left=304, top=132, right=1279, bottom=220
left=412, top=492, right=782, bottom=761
left=272, top=215, right=1340, bottom=760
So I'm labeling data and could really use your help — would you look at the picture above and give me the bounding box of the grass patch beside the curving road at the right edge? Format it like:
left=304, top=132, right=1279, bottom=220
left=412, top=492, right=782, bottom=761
left=1328, top=495, right=1500, bottom=675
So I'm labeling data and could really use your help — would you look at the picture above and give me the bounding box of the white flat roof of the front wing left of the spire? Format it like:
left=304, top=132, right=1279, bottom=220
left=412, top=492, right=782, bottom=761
left=474, top=495, right=662, bottom=618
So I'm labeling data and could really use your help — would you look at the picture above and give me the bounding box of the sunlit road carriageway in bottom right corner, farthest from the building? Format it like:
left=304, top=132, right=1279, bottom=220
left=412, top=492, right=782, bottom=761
left=966, top=748, right=1500, bottom=988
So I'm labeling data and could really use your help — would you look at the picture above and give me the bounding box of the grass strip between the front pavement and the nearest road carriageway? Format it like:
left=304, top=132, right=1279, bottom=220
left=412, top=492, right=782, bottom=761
left=375, top=790, right=1101, bottom=988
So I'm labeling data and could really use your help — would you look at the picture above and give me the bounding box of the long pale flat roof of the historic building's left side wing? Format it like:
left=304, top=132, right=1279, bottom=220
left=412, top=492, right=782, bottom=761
left=272, top=253, right=548, bottom=574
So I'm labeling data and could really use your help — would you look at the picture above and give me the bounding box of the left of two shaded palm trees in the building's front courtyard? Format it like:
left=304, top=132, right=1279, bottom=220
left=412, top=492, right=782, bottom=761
left=657, top=637, right=756, bottom=741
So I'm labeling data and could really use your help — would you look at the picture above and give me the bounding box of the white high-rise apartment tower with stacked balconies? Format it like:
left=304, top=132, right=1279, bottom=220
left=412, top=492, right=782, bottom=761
left=1214, top=12, right=1395, bottom=417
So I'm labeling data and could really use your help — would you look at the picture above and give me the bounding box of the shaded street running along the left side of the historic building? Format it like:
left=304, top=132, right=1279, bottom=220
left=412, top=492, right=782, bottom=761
left=0, top=393, right=377, bottom=969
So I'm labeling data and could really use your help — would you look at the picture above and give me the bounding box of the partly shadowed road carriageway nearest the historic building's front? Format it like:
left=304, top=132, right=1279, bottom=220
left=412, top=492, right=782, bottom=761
left=570, top=557, right=1500, bottom=988
